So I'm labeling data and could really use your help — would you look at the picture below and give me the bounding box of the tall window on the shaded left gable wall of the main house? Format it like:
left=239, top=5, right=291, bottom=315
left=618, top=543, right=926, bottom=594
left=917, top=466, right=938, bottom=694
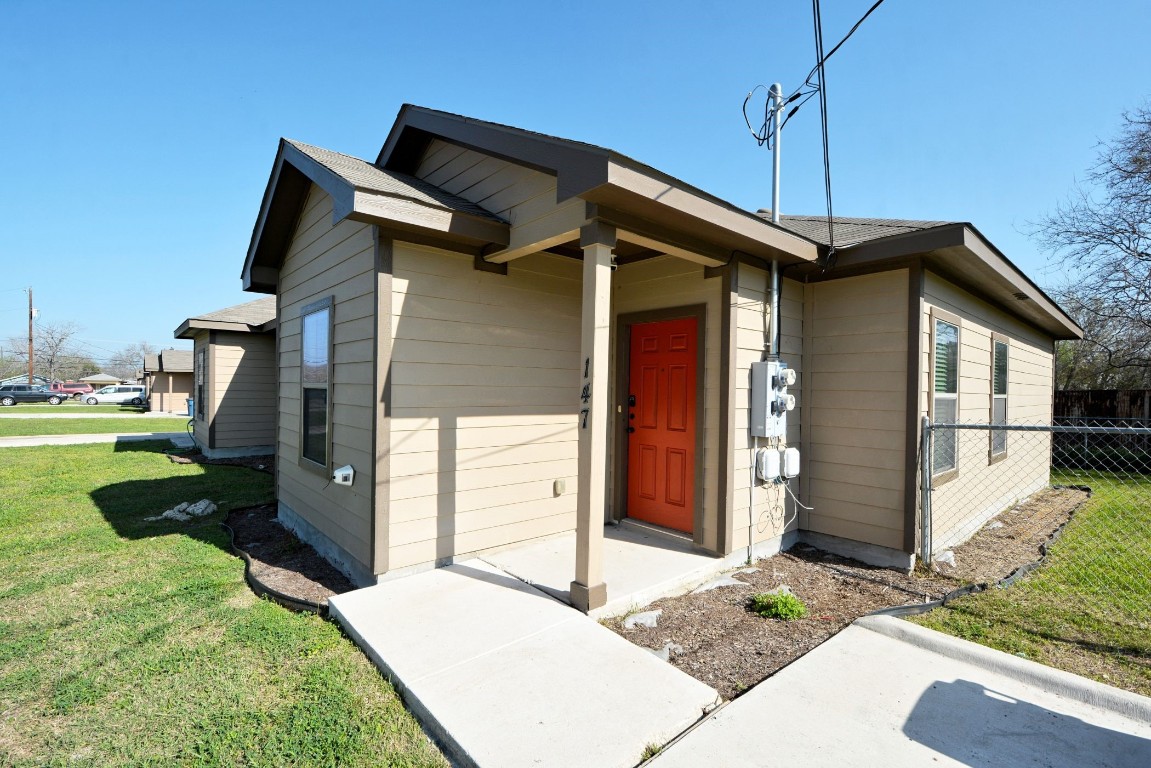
left=300, top=298, right=331, bottom=469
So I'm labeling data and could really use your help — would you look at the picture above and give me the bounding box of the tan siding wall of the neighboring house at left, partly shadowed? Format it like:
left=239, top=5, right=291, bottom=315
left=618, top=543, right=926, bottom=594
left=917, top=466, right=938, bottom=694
left=211, top=332, right=276, bottom=448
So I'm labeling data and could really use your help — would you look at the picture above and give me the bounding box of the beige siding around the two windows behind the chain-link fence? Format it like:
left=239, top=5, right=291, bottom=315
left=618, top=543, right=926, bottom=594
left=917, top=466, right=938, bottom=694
left=921, top=273, right=1054, bottom=552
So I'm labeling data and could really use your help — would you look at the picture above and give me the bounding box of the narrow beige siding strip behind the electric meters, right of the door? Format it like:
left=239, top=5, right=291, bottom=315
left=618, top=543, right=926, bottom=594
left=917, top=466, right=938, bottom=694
left=731, top=264, right=807, bottom=547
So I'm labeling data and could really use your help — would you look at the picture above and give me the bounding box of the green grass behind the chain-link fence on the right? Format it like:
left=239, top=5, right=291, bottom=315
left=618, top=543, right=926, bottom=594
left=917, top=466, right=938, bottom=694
left=913, top=472, right=1151, bottom=695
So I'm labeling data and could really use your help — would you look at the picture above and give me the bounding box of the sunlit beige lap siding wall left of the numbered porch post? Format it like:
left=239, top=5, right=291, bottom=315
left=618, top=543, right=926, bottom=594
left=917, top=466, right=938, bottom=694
left=388, top=243, right=581, bottom=569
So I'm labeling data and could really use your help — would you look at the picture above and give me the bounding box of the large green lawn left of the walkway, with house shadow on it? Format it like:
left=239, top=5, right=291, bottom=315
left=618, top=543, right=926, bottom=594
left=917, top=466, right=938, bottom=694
left=0, top=442, right=445, bottom=767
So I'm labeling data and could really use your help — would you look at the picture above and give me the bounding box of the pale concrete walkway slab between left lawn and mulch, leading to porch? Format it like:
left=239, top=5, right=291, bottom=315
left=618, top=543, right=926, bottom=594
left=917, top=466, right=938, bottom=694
left=329, top=560, right=718, bottom=767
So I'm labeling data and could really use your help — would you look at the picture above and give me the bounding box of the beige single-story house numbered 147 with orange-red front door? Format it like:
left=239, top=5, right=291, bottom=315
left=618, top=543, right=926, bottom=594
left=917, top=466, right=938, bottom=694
left=233, top=105, right=1080, bottom=610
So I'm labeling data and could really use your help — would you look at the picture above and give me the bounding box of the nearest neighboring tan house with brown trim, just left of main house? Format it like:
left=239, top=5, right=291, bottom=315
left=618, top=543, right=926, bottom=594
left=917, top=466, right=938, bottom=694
left=175, top=297, right=276, bottom=458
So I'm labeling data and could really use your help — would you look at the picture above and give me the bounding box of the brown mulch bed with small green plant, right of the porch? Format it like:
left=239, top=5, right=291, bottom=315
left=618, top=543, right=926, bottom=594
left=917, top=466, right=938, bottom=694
left=605, top=489, right=1087, bottom=699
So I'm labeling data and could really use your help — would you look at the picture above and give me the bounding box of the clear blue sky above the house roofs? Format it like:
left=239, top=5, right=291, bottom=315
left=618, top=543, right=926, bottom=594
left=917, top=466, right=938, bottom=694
left=0, top=0, right=1151, bottom=359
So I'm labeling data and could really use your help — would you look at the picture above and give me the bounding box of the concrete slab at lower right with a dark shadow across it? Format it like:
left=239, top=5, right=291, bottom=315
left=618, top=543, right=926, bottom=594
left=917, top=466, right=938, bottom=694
left=651, top=616, right=1151, bottom=768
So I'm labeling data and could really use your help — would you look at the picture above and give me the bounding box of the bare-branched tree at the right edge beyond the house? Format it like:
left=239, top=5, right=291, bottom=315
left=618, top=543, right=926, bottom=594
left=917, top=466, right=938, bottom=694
left=1032, top=104, right=1151, bottom=389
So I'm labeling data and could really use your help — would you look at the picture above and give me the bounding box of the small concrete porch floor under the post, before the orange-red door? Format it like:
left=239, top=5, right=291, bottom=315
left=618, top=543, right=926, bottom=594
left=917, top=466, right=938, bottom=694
left=482, top=525, right=744, bottom=618
